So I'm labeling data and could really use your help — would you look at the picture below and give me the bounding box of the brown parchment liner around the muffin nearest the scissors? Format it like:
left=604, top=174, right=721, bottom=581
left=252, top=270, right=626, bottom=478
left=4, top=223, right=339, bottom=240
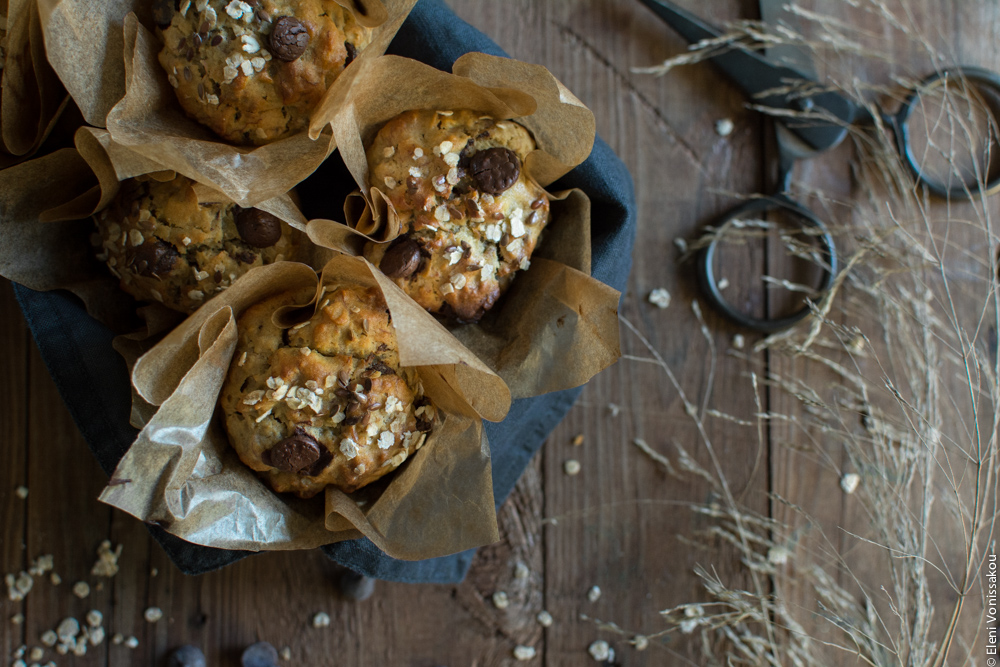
left=308, top=53, right=621, bottom=398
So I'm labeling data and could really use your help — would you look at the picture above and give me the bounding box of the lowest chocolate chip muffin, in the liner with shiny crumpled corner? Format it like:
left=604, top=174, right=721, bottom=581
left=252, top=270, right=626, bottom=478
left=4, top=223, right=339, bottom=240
left=220, top=286, right=437, bottom=498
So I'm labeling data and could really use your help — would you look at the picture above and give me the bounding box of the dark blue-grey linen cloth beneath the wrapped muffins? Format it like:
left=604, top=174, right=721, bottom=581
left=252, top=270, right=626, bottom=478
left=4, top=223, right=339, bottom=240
left=15, top=0, right=636, bottom=583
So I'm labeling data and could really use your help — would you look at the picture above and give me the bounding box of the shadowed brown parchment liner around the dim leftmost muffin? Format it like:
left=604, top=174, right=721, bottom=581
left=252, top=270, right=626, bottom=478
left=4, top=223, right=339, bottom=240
left=0, top=127, right=312, bottom=332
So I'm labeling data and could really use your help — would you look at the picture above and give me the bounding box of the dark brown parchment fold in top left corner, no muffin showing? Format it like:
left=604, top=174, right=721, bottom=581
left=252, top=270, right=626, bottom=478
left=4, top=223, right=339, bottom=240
left=0, top=0, right=69, bottom=169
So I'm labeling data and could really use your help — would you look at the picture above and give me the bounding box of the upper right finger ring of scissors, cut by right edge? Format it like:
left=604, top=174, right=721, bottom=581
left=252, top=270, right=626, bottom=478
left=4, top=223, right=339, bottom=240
left=893, top=66, right=1000, bottom=199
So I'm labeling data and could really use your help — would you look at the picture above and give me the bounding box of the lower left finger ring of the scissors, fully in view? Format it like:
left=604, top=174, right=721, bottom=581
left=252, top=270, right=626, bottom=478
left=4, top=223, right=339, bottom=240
left=698, top=195, right=837, bottom=333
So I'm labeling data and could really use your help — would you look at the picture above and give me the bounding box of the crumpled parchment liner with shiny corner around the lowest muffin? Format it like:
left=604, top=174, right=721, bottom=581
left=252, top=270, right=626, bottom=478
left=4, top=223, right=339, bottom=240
left=101, top=255, right=509, bottom=560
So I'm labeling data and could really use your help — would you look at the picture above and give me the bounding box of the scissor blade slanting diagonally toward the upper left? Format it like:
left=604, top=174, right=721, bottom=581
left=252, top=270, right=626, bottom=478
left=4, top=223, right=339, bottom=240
left=640, top=0, right=857, bottom=151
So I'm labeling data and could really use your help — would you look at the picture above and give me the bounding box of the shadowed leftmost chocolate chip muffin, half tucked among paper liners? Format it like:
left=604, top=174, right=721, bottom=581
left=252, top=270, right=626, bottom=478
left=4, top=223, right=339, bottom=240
left=95, top=175, right=296, bottom=313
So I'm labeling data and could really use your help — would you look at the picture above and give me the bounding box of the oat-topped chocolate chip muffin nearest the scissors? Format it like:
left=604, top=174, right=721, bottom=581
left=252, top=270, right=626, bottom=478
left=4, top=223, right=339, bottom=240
left=365, top=110, right=549, bottom=322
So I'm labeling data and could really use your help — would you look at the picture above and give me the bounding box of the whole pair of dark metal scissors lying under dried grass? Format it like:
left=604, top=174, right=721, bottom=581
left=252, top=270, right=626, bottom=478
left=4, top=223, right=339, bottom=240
left=641, top=0, right=1000, bottom=333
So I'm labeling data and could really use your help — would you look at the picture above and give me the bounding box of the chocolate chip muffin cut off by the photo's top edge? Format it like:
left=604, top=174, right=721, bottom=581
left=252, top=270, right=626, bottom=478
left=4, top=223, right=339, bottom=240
left=153, top=0, right=372, bottom=145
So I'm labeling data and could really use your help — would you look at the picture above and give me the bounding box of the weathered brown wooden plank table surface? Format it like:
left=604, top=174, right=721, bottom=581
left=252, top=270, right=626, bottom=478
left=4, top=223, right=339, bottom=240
left=0, top=0, right=1000, bottom=667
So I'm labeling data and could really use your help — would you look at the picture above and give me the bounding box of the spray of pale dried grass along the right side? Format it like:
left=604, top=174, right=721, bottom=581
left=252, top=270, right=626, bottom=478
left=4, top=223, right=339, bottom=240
left=620, top=0, right=1000, bottom=667
